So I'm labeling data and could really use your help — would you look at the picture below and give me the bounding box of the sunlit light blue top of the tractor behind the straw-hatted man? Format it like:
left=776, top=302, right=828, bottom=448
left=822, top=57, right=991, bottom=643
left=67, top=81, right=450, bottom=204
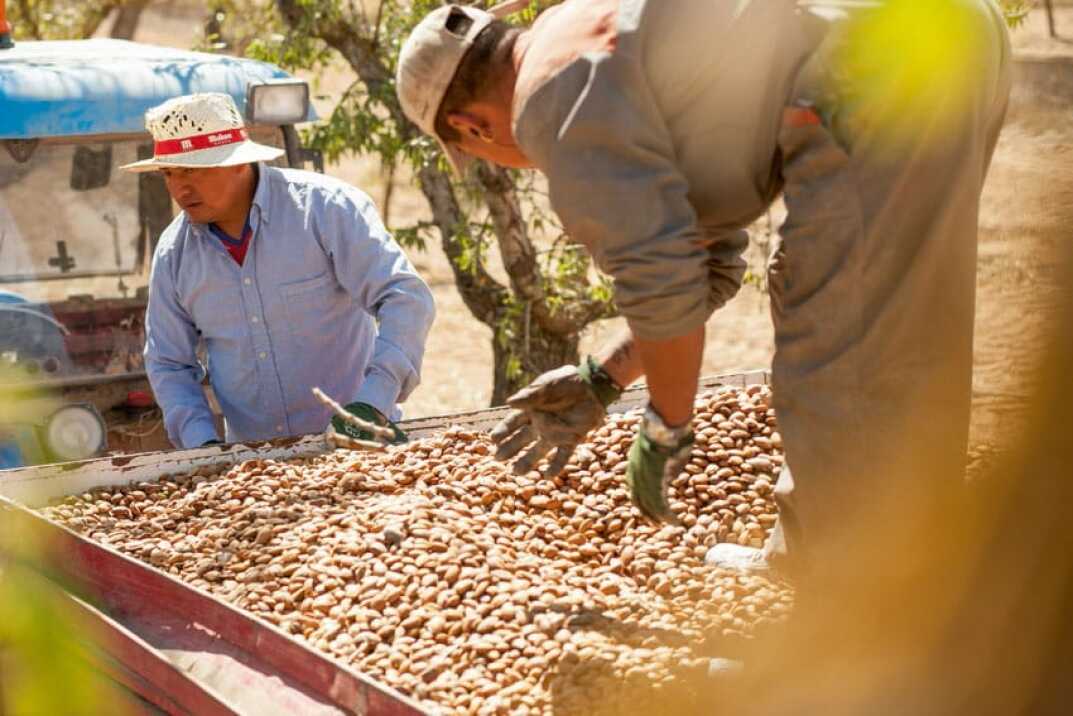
left=0, top=40, right=317, bottom=140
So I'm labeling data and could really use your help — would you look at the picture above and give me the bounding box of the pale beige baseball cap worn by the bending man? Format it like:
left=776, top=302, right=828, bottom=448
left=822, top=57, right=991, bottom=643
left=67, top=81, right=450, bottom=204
left=395, top=0, right=529, bottom=175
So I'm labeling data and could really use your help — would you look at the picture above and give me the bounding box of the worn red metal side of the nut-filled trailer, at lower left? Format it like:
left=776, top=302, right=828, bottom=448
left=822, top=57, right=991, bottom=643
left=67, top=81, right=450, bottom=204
left=0, top=497, right=427, bottom=716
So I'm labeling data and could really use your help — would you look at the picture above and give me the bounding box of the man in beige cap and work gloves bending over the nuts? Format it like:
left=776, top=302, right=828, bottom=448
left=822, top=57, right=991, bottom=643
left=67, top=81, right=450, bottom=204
left=397, top=0, right=1010, bottom=583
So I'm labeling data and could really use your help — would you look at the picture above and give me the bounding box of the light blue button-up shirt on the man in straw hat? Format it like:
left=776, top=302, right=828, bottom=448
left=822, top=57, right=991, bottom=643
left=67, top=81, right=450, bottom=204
left=145, top=164, right=436, bottom=448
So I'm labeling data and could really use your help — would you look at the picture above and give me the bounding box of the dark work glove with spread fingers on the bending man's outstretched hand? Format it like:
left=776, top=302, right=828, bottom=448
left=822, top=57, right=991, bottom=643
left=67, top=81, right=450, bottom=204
left=491, top=355, right=622, bottom=477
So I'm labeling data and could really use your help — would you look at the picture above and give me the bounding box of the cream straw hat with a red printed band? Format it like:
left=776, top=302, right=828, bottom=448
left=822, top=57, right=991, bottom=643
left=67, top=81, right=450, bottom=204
left=122, top=92, right=283, bottom=172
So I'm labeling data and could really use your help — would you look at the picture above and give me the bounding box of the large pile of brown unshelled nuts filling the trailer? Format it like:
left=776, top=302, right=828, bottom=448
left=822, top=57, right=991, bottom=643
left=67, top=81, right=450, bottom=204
left=46, top=385, right=792, bottom=714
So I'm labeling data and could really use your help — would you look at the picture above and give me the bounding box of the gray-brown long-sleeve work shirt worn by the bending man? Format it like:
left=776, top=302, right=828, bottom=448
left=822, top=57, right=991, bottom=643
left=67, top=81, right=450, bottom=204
left=514, top=0, right=823, bottom=339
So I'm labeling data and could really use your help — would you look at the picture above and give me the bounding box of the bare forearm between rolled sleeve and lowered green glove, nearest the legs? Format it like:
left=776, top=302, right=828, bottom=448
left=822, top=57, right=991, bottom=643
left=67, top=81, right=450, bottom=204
left=634, top=325, right=704, bottom=427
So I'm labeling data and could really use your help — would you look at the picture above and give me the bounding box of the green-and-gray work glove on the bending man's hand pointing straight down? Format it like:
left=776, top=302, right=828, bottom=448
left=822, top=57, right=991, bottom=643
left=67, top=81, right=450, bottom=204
left=626, top=406, right=693, bottom=525
